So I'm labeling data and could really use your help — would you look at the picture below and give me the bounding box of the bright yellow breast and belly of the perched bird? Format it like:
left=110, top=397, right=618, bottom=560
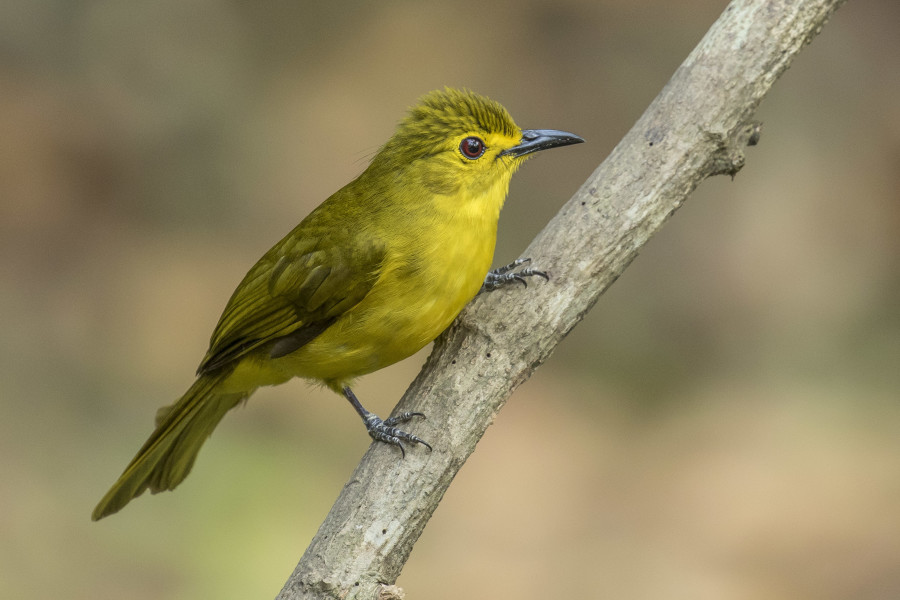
left=225, top=178, right=506, bottom=391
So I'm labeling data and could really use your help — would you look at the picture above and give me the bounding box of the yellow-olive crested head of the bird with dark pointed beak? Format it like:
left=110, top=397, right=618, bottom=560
left=372, top=88, right=584, bottom=195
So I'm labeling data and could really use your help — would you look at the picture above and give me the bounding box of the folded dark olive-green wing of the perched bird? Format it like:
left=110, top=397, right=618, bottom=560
left=197, top=230, right=385, bottom=374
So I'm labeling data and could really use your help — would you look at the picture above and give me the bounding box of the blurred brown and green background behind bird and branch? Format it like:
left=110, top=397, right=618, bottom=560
left=0, top=0, right=900, bottom=600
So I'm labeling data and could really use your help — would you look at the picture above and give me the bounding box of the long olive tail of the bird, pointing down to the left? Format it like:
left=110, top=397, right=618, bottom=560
left=91, top=370, right=249, bottom=521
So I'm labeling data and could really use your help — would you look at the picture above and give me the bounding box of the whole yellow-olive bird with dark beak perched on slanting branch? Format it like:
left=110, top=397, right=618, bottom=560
left=92, top=87, right=584, bottom=521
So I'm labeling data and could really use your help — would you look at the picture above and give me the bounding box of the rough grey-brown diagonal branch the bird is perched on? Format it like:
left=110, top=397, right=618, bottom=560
left=278, top=0, right=841, bottom=600
